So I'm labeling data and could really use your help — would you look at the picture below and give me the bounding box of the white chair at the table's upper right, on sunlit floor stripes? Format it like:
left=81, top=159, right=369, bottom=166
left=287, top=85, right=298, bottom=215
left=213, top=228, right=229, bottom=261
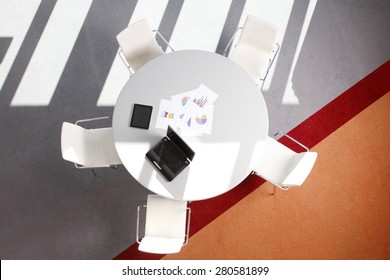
left=223, top=15, right=280, bottom=87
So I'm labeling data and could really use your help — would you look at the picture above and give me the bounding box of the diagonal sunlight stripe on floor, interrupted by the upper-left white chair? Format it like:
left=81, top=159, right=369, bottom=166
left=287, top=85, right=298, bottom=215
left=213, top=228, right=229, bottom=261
left=96, top=0, right=168, bottom=106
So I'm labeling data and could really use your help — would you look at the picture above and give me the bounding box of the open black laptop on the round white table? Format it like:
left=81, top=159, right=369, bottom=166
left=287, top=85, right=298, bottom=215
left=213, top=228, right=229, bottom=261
left=146, top=126, right=195, bottom=181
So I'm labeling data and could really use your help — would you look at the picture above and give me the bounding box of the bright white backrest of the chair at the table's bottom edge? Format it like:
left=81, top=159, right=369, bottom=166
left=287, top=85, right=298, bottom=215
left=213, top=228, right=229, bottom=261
left=138, top=236, right=184, bottom=254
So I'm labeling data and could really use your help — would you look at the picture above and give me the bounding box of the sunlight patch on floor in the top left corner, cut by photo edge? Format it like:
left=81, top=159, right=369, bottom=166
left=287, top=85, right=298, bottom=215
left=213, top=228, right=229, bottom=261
left=0, top=0, right=41, bottom=92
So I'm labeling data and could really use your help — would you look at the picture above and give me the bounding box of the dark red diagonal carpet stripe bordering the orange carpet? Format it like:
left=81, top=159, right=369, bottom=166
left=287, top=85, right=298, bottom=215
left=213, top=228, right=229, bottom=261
left=114, top=61, right=390, bottom=260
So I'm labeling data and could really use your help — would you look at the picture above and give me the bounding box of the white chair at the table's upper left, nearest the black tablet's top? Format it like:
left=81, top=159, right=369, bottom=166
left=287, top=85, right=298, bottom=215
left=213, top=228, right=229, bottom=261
left=116, top=19, right=174, bottom=74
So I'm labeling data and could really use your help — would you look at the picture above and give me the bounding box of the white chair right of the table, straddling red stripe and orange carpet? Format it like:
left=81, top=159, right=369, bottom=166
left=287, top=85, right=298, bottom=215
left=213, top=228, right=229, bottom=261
left=253, top=132, right=317, bottom=190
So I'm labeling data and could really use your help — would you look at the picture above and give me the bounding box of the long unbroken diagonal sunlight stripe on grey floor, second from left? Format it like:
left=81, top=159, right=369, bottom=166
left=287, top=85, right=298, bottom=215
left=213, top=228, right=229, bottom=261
left=11, top=0, right=92, bottom=106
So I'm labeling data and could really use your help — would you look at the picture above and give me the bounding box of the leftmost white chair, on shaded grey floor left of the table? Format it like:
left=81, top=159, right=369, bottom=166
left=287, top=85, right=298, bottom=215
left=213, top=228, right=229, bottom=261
left=61, top=117, right=122, bottom=175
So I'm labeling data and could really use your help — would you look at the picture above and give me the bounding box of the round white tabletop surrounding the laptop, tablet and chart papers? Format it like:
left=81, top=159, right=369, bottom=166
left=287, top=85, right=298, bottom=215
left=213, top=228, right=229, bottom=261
left=113, top=50, right=268, bottom=201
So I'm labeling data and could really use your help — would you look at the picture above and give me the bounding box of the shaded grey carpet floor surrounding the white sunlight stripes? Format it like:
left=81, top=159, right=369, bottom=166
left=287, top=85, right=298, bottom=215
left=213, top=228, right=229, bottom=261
left=0, top=0, right=390, bottom=259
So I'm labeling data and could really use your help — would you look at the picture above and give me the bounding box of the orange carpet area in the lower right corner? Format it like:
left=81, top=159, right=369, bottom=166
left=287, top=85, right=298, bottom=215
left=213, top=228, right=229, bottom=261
left=163, top=93, right=390, bottom=259
